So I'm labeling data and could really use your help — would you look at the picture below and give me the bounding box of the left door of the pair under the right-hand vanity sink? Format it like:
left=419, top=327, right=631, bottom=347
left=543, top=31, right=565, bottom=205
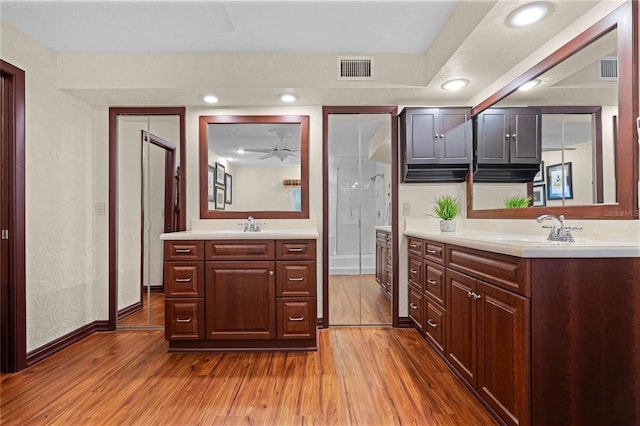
left=446, top=269, right=478, bottom=387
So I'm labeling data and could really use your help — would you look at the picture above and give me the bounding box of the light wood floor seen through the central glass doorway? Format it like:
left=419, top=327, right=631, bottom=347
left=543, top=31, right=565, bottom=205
left=329, top=275, right=391, bottom=325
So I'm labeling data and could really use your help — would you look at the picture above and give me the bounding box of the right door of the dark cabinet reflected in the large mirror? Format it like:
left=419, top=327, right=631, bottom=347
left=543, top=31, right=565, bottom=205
left=510, top=108, right=542, bottom=164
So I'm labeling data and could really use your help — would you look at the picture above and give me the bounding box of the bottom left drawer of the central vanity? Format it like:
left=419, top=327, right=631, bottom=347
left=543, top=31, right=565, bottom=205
left=164, top=299, right=204, bottom=340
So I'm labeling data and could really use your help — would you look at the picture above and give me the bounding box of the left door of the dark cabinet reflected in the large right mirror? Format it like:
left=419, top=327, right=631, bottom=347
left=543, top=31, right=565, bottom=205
left=476, top=108, right=511, bottom=164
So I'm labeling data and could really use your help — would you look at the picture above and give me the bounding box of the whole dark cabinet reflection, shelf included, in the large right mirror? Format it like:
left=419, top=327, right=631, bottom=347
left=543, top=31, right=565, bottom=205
left=473, top=108, right=542, bottom=182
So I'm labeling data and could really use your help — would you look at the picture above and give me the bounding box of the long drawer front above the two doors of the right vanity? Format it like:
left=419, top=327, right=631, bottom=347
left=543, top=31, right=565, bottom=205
left=447, top=245, right=531, bottom=297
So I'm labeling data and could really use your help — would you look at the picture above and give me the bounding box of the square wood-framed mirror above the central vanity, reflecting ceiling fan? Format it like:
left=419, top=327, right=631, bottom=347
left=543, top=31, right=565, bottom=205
left=200, top=115, right=309, bottom=219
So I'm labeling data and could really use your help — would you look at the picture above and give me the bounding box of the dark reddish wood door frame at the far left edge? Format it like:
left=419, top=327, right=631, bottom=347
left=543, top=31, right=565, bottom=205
left=0, top=59, right=27, bottom=372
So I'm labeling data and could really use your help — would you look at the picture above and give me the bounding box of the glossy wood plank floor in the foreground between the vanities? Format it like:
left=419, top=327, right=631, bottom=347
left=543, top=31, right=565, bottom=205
left=0, top=327, right=495, bottom=426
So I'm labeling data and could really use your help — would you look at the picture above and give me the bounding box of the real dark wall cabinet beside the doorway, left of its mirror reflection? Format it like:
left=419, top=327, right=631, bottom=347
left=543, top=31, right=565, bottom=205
left=400, top=108, right=472, bottom=182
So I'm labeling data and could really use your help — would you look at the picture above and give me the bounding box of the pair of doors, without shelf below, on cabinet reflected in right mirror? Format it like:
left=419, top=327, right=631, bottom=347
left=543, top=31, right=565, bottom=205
left=476, top=108, right=542, bottom=164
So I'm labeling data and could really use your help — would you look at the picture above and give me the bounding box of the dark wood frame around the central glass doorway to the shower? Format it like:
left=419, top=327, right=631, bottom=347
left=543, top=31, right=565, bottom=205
left=322, top=106, right=399, bottom=328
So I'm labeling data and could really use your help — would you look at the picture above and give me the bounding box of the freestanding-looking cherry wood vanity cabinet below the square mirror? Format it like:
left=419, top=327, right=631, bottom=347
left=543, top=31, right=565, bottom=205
left=165, top=240, right=317, bottom=350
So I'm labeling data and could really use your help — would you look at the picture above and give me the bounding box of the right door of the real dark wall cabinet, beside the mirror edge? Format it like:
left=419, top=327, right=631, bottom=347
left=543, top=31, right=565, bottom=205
left=436, top=108, right=473, bottom=164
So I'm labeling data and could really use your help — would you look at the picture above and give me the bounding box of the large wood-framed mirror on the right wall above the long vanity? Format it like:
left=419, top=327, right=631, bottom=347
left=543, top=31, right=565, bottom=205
left=467, top=2, right=638, bottom=219
